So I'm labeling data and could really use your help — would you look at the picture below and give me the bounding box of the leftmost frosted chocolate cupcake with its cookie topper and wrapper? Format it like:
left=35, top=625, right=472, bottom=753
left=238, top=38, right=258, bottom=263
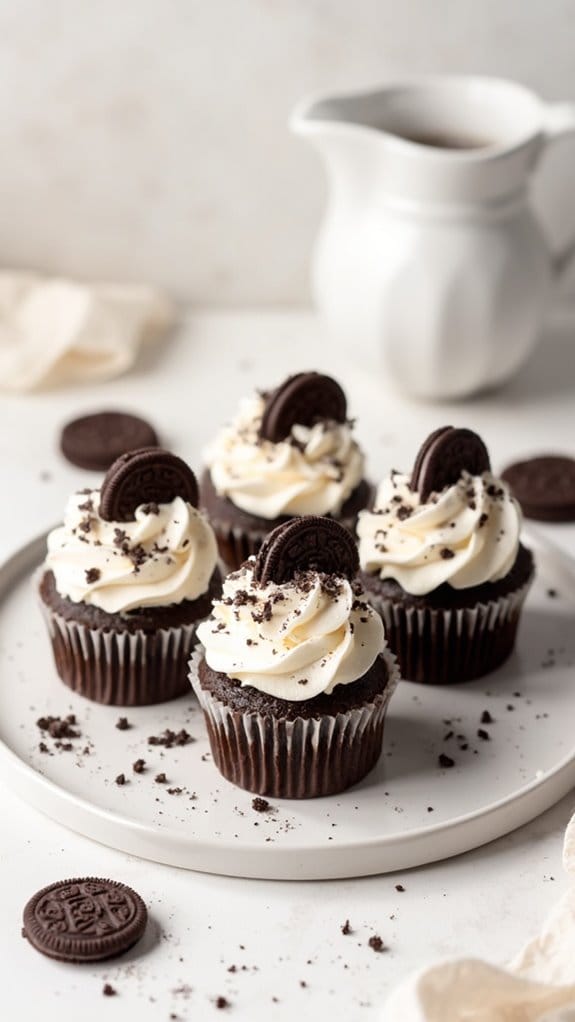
left=40, top=448, right=221, bottom=706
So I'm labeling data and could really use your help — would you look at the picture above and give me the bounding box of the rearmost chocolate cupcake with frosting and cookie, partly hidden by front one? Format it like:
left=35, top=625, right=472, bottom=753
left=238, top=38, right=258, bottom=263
left=200, top=373, right=372, bottom=569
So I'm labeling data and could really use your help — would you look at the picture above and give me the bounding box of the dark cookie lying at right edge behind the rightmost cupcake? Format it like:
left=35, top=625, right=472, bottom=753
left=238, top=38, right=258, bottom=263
left=501, top=455, right=575, bottom=522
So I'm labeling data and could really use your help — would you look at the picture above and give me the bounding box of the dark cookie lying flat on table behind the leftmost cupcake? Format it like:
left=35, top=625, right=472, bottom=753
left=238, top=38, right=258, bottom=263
left=60, top=412, right=158, bottom=472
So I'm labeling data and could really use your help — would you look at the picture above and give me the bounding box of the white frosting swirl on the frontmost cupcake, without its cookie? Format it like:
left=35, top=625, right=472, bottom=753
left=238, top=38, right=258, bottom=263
left=198, top=559, right=384, bottom=702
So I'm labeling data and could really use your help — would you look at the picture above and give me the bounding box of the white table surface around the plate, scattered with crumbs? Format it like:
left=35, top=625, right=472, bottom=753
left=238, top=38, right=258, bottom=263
left=0, top=312, right=575, bottom=1022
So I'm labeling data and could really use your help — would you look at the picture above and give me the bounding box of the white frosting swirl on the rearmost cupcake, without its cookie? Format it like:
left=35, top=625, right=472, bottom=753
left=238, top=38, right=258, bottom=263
left=205, top=396, right=364, bottom=519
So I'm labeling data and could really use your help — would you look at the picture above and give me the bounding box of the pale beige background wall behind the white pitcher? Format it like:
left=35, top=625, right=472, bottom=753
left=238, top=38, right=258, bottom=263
left=0, top=0, right=575, bottom=305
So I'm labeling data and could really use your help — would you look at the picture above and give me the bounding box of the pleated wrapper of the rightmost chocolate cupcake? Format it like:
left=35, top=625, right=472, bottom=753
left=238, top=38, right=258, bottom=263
left=367, top=575, right=533, bottom=685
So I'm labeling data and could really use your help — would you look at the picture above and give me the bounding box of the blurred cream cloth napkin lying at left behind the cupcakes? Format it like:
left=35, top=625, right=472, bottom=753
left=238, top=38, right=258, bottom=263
left=0, top=271, right=175, bottom=391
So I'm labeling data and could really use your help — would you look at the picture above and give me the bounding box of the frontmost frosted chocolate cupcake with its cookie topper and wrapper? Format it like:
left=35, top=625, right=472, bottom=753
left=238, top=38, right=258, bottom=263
left=191, top=516, right=397, bottom=798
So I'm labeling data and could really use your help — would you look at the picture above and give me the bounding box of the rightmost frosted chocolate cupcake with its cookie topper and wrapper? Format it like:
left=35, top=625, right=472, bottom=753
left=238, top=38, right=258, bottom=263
left=357, top=426, right=534, bottom=685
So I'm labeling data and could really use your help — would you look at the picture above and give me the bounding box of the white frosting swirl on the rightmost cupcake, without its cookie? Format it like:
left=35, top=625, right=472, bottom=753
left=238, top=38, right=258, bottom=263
left=357, top=472, right=521, bottom=596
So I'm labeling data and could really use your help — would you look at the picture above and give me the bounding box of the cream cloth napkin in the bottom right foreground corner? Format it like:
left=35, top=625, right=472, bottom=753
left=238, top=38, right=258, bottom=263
left=381, top=816, right=575, bottom=1022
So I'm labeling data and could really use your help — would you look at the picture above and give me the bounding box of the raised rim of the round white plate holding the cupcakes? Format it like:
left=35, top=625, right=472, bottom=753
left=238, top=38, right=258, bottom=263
left=0, top=529, right=575, bottom=880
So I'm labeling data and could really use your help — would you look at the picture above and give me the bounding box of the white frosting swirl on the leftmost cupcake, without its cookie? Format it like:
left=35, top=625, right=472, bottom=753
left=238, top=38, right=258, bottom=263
left=46, top=490, right=218, bottom=614
